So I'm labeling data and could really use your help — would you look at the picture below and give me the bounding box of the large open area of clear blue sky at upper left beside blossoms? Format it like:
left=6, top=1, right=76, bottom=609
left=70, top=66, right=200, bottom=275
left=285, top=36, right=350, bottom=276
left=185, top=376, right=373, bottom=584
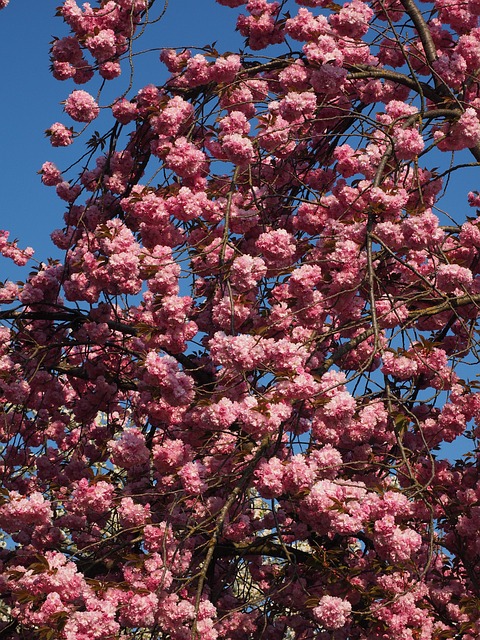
left=0, top=0, right=243, bottom=281
